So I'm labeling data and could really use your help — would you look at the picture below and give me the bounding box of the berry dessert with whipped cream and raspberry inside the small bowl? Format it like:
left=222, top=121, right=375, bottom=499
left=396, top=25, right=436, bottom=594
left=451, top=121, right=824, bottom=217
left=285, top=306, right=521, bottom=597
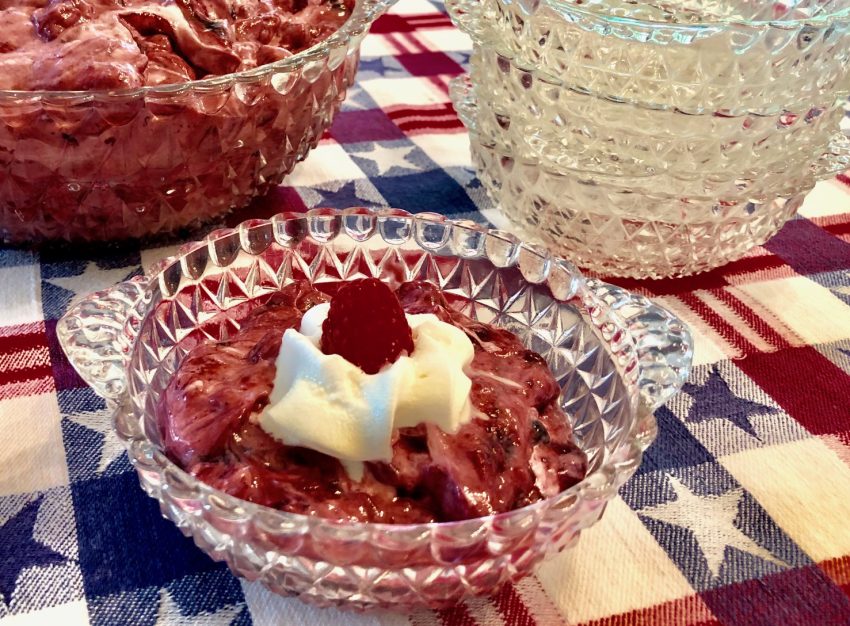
left=159, top=279, right=587, bottom=523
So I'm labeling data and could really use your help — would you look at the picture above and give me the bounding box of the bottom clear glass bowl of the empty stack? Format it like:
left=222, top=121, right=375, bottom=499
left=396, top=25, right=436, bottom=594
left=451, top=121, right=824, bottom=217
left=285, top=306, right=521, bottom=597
left=470, top=133, right=811, bottom=278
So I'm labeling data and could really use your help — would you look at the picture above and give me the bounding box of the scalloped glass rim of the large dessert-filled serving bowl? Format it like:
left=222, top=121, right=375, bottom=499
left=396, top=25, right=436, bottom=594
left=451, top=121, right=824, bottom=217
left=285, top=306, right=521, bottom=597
left=0, top=0, right=398, bottom=104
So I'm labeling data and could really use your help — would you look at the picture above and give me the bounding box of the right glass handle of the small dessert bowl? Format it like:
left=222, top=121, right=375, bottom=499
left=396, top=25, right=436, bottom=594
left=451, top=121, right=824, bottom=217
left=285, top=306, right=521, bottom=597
left=587, top=279, right=694, bottom=411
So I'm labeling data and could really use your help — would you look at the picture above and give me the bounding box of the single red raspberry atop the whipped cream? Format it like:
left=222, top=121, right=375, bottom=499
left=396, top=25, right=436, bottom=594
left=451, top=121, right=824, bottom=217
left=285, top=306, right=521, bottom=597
left=322, top=278, right=413, bottom=374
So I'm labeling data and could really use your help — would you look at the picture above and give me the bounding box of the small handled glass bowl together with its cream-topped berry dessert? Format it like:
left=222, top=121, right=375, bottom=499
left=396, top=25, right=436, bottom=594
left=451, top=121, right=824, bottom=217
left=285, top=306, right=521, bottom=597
left=57, top=208, right=692, bottom=609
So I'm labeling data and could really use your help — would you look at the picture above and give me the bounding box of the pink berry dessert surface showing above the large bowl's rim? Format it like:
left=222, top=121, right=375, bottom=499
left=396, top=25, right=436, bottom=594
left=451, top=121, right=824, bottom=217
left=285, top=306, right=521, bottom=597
left=0, top=0, right=353, bottom=91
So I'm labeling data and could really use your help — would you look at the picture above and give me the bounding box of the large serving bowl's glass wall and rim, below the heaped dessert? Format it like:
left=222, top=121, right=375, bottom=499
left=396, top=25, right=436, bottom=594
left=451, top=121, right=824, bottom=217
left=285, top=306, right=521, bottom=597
left=0, top=0, right=394, bottom=244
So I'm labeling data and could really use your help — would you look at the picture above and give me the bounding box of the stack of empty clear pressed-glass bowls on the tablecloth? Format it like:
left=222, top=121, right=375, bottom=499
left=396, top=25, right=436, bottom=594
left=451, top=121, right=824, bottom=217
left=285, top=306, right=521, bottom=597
left=448, top=0, right=850, bottom=277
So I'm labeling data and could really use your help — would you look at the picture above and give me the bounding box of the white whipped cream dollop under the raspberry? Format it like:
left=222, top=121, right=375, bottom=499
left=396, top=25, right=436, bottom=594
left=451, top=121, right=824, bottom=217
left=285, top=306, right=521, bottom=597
left=257, top=304, right=474, bottom=480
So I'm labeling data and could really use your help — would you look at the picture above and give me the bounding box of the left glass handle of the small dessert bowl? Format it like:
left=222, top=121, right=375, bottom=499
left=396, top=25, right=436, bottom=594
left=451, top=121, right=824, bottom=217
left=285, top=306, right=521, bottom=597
left=56, top=276, right=149, bottom=400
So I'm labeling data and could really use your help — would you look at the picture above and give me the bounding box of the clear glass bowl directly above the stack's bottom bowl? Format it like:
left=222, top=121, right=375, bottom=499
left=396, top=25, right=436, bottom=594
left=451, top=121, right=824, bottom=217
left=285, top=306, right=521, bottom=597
left=469, top=46, right=844, bottom=188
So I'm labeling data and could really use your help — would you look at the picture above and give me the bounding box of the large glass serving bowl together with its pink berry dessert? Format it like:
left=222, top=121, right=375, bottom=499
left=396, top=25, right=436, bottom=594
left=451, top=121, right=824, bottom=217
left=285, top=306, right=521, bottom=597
left=0, top=0, right=394, bottom=245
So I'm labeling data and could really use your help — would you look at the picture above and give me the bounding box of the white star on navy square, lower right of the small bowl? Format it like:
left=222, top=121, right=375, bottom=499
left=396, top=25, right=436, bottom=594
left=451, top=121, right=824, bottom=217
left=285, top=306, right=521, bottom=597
left=638, top=476, right=787, bottom=577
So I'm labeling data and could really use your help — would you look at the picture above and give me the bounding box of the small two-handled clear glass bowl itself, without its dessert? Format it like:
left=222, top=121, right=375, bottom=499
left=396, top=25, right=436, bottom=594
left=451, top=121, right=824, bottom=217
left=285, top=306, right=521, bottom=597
left=57, top=208, right=692, bottom=609
